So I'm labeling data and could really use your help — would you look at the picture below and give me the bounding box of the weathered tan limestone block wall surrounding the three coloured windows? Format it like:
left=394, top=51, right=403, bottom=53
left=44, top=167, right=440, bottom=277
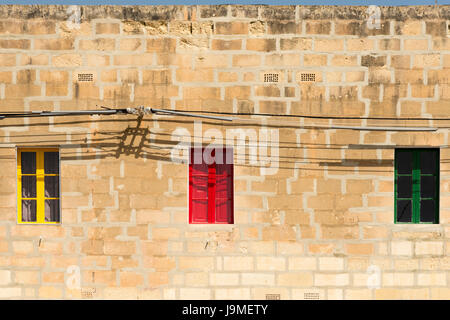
left=0, top=5, right=450, bottom=299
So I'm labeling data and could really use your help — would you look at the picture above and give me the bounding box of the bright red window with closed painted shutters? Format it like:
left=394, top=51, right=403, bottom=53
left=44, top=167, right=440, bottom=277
left=189, top=148, right=233, bottom=223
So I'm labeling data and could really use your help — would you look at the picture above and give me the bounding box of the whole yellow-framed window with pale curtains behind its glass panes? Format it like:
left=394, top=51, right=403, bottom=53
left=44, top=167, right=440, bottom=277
left=17, top=148, right=60, bottom=224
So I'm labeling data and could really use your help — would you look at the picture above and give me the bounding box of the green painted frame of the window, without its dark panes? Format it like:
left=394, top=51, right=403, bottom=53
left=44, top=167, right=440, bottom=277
left=394, top=148, right=441, bottom=224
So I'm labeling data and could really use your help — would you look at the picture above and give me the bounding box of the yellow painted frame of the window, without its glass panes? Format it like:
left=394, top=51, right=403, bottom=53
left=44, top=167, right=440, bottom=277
left=16, top=147, right=62, bottom=225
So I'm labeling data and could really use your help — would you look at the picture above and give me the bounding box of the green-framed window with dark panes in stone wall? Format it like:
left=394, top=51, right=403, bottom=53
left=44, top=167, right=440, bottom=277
left=394, top=149, right=439, bottom=223
